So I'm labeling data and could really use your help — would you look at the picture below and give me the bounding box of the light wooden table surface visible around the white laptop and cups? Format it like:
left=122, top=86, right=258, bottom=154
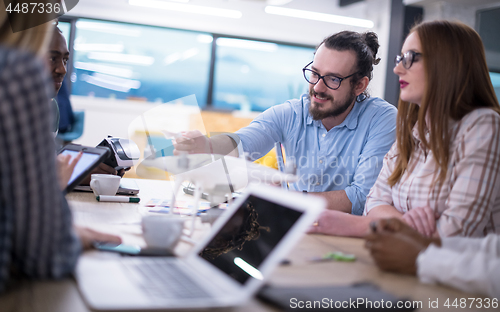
left=0, top=179, right=497, bottom=312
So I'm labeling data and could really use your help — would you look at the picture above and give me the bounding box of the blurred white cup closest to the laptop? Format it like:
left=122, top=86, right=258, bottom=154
left=142, top=215, right=186, bottom=250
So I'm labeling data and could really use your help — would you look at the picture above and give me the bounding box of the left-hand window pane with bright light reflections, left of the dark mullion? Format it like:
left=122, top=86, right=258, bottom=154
left=71, top=19, right=212, bottom=107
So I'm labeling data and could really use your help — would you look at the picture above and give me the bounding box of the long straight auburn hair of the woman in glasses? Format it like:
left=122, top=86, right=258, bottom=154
left=388, top=21, right=500, bottom=186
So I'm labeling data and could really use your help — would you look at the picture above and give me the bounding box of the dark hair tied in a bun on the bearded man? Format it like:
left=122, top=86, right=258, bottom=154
left=316, top=30, right=380, bottom=100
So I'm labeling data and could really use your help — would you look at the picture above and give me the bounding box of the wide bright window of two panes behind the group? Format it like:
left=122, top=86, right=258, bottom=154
left=59, top=18, right=315, bottom=111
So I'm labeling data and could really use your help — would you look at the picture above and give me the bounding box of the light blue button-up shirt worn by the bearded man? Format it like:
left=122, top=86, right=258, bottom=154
left=236, top=94, right=397, bottom=215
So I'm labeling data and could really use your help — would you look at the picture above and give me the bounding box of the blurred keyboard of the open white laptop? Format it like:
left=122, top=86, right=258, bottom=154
left=122, top=258, right=210, bottom=299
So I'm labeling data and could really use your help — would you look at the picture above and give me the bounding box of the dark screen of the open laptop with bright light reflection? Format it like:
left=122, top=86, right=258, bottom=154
left=200, top=195, right=302, bottom=284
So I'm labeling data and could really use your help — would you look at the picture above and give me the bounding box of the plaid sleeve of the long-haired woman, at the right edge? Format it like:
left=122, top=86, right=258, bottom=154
left=437, top=109, right=500, bottom=237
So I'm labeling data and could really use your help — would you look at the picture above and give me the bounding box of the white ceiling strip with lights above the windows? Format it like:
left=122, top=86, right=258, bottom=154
left=67, top=0, right=376, bottom=46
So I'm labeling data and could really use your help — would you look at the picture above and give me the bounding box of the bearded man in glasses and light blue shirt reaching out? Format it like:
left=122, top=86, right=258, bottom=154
left=176, top=31, right=397, bottom=215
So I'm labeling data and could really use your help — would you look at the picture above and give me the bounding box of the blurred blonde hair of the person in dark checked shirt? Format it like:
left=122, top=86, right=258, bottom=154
left=0, top=1, right=54, bottom=57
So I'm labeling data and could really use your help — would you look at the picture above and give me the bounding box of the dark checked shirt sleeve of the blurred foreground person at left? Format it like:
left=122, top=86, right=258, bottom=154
left=0, top=49, right=80, bottom=291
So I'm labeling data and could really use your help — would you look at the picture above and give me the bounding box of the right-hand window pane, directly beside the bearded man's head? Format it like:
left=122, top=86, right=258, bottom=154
left=213, top=37, right=314, bottom=111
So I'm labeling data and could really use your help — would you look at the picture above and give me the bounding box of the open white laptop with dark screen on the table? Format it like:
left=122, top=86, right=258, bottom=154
left=75, top=185, right=325, bottom=311
